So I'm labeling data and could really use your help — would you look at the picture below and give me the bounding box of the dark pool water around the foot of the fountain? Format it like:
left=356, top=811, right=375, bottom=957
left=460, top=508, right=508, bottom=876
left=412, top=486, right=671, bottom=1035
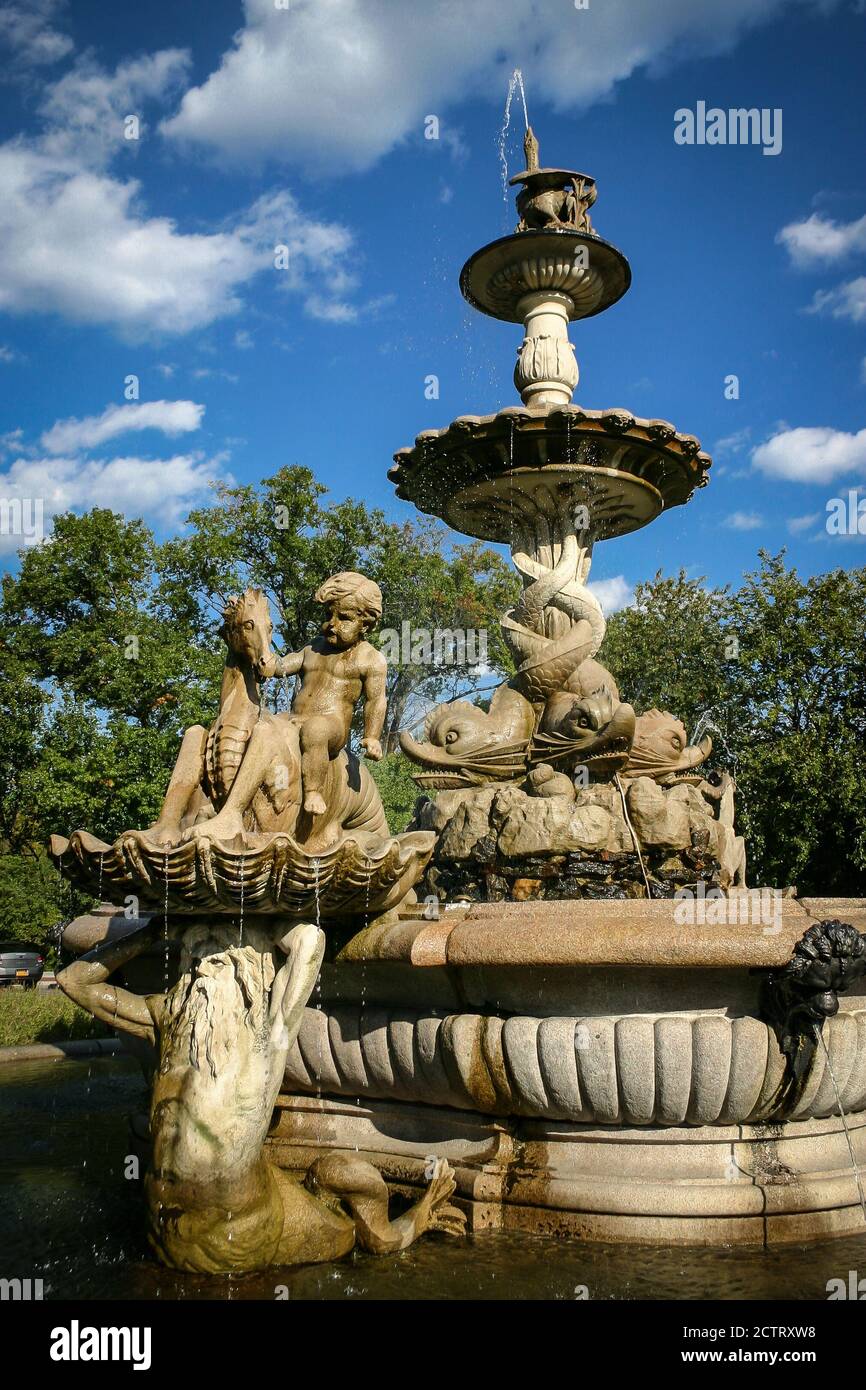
left=0, top=1058, right=866, bottom=1300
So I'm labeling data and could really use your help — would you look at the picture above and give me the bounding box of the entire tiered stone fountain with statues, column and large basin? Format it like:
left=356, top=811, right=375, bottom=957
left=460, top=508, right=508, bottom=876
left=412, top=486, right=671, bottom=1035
left=53, top=131, right=866, bottom=1272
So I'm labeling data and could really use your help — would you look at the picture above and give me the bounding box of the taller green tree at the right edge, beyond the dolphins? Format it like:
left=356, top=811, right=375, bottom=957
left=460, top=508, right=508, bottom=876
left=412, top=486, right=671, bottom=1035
left=727, top=552, right=866, bottom=897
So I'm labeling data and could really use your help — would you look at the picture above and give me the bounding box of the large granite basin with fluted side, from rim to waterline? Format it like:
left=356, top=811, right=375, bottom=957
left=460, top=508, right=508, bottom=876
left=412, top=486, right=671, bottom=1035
left=262, top=899, right=866, bottom=1244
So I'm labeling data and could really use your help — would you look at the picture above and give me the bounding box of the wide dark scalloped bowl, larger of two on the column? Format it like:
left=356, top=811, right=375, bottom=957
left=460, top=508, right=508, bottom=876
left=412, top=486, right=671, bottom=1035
left=388, top=406, right=712, bottom=542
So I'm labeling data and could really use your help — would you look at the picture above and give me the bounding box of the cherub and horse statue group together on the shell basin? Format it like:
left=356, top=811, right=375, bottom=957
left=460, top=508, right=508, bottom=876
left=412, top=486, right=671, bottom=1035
left=147, top=571, right=389, bottom=849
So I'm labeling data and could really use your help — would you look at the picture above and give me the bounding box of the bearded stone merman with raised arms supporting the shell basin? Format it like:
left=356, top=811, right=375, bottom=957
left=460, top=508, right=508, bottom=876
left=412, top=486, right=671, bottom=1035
left=57, top=915, right=464, bottom=1273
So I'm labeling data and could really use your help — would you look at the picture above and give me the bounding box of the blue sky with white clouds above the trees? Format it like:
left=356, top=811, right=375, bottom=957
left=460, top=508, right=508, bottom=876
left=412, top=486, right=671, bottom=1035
left=0, top=0, right=866, bottom=605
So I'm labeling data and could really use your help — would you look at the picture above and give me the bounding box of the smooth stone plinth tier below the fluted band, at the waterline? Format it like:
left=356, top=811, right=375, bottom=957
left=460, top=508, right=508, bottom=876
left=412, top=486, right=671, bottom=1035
left=265, top=1095, right=866, bottom=1245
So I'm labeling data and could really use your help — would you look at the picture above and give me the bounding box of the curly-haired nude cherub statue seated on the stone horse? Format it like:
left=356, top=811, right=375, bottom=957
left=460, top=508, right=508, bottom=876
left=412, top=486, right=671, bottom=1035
left=259, top=570, right=386, bottom=816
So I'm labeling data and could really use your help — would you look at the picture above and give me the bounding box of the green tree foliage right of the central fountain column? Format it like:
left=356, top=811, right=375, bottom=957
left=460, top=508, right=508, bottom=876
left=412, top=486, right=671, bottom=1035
left=602, top=552, right=866, bottom=897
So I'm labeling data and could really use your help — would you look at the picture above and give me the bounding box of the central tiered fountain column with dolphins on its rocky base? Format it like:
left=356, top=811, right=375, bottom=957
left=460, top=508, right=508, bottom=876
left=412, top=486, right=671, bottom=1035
left=389, top=129, right=745, bottom=901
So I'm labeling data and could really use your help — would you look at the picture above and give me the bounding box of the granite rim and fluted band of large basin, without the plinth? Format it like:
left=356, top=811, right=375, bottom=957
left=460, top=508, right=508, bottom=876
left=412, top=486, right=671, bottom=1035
left=285, top=899, right=866, bottom=1126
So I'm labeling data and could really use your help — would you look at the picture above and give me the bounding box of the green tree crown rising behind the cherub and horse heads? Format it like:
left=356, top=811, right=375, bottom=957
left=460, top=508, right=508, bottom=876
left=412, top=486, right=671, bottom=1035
left=158, top=466, right=520, bottom=752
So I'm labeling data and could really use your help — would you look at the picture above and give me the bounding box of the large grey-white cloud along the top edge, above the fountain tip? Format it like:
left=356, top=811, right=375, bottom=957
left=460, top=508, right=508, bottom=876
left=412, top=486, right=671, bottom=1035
left=163, top=0, right=833, bottom=174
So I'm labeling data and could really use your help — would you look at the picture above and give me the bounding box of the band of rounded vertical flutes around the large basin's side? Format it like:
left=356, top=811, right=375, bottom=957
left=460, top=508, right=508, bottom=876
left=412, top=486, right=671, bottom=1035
left=285, top=1005, right=866, bottom=1126
